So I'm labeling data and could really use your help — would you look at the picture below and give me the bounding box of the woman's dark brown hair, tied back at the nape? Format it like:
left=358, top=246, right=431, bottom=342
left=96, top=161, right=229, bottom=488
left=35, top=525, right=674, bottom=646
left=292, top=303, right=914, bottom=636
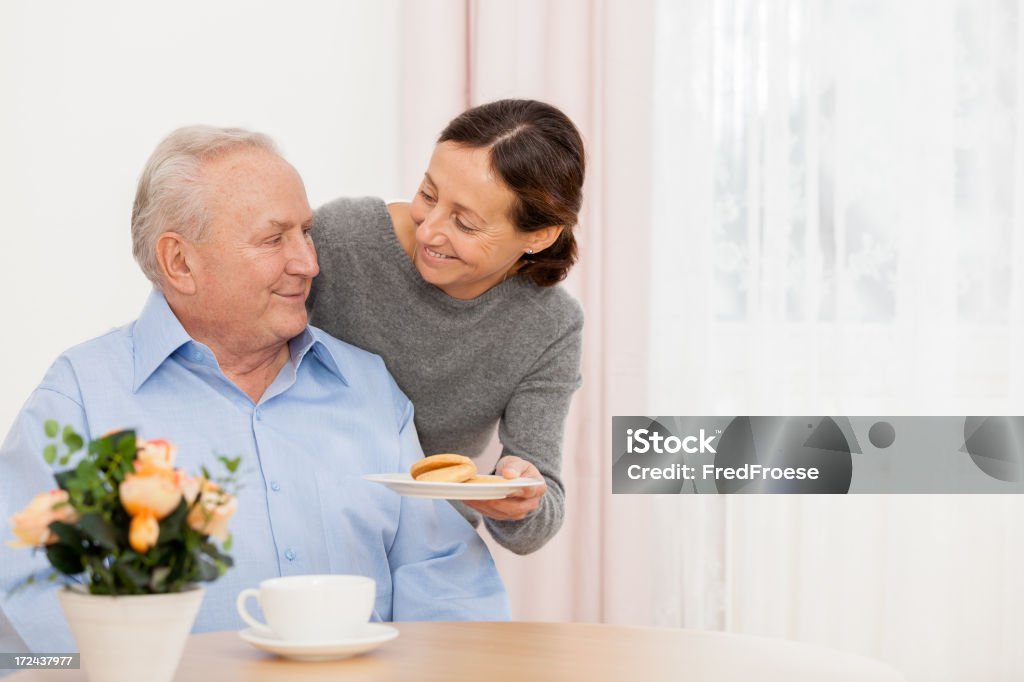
left=437, top=99, right=586, bottom=287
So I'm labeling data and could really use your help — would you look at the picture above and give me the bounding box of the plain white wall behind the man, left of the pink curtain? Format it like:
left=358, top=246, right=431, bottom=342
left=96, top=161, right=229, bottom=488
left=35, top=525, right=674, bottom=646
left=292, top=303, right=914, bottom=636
left=0, top=0, right=403, bottom=434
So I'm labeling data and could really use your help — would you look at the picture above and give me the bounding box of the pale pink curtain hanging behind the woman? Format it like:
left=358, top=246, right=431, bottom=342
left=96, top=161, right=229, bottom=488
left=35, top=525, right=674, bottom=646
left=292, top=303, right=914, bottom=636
left=396, top=0, right=658, bottom=624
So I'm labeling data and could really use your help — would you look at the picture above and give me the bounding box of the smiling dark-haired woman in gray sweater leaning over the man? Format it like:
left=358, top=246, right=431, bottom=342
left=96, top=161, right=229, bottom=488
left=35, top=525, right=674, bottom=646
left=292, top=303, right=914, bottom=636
left=309, top=99, right=585, bottom=554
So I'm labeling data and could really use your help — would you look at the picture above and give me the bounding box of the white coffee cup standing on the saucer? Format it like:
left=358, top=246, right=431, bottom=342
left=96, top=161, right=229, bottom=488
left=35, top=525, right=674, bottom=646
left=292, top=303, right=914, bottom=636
left=236, top=576, right=377, bottom=642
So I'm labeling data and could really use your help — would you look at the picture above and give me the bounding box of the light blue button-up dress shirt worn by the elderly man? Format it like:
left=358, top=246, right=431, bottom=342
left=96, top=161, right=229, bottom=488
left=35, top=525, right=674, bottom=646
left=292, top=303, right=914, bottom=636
left=0, top=292, right=509, bottom=652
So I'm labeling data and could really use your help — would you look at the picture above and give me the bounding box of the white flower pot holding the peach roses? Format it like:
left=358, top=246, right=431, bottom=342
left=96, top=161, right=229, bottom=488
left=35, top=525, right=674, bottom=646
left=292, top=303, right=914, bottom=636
left=57, top=586, right=204, bottom=682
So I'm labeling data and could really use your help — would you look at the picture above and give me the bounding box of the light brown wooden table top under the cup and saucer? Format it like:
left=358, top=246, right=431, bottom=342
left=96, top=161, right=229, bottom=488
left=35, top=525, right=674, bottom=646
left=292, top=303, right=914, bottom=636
left=8, top=623, right=903, bottom=682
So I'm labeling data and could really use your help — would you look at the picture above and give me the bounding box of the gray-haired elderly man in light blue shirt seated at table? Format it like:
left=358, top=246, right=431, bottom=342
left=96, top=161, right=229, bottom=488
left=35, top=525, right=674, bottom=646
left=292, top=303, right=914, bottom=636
left=0, top=127, right=508, bottom=651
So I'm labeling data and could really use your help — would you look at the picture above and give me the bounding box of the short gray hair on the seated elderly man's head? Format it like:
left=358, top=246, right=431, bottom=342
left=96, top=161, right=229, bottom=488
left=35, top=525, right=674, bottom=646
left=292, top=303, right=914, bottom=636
left=131, top=126, right=281, bottom=287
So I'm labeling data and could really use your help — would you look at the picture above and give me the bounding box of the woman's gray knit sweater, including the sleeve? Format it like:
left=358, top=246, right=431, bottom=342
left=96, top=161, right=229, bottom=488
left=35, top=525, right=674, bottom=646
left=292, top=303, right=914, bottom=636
left=309, top=198, right=583, bottom=554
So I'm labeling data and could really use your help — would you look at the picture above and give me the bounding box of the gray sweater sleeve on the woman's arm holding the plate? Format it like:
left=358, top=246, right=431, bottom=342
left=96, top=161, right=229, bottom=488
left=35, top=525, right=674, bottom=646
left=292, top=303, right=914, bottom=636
left=483, top=301, right=583, bottom=554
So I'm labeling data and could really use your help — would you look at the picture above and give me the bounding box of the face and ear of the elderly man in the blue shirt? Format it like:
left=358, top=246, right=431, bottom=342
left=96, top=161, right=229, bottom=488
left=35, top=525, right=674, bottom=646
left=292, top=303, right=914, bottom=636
left=184, top=150, right=319, bottom=352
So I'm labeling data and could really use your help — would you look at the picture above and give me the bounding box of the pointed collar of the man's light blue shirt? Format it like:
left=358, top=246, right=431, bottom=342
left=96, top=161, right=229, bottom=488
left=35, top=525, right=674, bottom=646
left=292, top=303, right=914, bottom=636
left=132, top=289, right=348, bottom=393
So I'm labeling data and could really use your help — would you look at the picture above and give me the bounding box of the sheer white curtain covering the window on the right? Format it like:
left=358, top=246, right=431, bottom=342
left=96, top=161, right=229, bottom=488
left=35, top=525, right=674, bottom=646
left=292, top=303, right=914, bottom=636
left=648, top=0, right=1024, bottom=681
